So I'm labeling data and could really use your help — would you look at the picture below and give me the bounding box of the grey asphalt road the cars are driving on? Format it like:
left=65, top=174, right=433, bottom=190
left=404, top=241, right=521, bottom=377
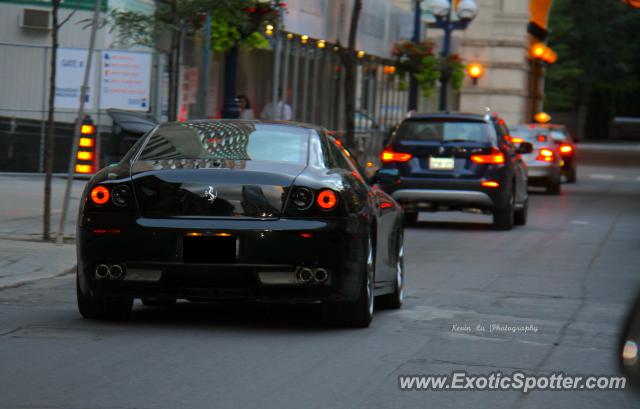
left=0, top=144, right=640, bottom=409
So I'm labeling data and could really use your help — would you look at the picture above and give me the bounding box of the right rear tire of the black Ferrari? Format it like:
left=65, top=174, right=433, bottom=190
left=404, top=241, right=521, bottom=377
left=324, top=234, right=375, bottom=328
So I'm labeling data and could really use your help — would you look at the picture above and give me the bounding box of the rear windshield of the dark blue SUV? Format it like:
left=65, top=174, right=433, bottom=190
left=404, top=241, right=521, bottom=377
left=396, top=119, right=492, bottom=143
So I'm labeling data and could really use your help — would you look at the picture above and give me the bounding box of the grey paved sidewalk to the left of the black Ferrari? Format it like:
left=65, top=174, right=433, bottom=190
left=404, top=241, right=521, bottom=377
left=0, top=174, right=86, bottom=290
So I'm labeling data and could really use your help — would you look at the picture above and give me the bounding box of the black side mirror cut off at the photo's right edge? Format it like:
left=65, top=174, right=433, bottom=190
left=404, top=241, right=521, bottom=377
left=618, top=297, right=640, bottom=390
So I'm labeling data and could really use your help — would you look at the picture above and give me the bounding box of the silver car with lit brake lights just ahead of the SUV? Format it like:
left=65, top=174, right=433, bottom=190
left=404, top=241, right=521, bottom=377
left=511, top=125, right=563, bottom=195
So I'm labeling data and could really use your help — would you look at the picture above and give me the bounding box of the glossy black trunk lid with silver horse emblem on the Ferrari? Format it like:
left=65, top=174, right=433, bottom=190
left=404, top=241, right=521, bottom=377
left=131, top=159, right=305, bottom=219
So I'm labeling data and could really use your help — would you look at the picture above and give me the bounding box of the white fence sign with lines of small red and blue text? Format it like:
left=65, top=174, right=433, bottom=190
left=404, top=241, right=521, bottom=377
left=100, top=51, right=151, bottom=111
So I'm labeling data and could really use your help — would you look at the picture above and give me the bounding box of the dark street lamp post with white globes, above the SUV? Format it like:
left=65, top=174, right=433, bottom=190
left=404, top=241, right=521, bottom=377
left=429, top=0, right=478, bottom=111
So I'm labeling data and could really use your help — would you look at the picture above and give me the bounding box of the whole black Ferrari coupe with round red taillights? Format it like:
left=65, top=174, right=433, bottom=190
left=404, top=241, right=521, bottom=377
left=77, top=120, right=404, bottom=326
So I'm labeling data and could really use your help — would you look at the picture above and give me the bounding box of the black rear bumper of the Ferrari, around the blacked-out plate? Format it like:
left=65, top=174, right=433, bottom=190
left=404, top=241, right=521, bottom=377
left=78, top=218, right=368, bottom=302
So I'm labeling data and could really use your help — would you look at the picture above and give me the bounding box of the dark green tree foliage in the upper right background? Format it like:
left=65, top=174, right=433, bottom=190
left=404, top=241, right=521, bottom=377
left=545, top=0, right=640, bottom=111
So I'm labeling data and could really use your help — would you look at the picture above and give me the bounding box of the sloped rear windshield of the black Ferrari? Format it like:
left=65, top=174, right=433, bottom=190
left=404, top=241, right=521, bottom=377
left=138, top=121, right=315, bottom=164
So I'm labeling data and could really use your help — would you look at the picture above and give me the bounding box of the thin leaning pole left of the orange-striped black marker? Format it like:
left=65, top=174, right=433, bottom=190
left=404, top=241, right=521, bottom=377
left=56, top=0, right=102, bottom=244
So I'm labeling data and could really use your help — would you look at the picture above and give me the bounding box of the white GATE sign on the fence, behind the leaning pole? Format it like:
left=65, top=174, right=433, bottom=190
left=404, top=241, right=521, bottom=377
left=55, top=48, right=95, bottom=109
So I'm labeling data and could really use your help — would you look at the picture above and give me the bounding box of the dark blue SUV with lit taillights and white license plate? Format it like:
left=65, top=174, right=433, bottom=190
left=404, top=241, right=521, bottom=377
left=378, top=112, right=532, bottom=230
